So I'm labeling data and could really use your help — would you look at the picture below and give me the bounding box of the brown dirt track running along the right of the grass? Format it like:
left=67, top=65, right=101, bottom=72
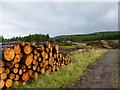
left=67, top=49, right=118, bottom=88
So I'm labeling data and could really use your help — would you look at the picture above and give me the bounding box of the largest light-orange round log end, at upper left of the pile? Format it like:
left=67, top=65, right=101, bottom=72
left=4, top=48, right=15, bottom=61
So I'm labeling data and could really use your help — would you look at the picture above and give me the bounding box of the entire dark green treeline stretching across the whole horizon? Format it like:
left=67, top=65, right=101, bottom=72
left=2, top=31, right=120, bottom=42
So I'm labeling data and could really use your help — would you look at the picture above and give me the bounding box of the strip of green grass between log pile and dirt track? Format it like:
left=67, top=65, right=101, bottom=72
left=12, top=49, right=107, bottom=88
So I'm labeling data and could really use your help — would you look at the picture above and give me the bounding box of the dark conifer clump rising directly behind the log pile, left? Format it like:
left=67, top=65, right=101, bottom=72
left=2, top=34, right=50, bottom=42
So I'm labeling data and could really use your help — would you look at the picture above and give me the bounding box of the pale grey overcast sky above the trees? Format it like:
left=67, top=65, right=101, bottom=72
left=0, top=2, right=118, bottom=38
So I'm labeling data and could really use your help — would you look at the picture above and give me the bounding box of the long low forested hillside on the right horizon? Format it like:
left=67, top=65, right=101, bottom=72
left=53, top=31, right=120, bottom=42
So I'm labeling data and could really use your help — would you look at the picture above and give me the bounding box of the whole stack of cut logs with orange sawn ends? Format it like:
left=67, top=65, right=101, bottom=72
left=0, top=41, right=71, bottom=88
